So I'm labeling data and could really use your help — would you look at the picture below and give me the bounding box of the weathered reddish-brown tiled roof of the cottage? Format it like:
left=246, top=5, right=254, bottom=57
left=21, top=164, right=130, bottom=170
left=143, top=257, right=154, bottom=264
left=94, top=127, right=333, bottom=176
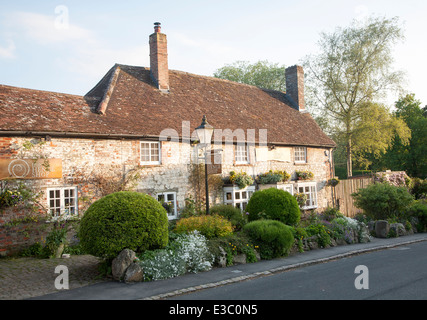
left=0, top=65, right=335, bottom=147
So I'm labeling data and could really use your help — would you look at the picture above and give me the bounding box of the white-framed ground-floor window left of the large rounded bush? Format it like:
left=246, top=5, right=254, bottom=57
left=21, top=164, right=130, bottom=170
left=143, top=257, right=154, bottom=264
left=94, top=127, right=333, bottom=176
left=46, top=187, right=79, bottom=219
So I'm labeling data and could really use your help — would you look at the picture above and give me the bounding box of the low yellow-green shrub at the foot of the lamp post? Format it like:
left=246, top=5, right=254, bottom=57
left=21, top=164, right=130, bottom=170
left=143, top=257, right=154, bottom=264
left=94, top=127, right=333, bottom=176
left=174, top=214, right=233, bottom=239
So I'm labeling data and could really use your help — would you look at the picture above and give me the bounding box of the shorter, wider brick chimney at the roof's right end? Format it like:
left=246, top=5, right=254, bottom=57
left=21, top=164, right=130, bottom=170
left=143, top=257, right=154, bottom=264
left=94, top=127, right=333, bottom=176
left=286, top=66, right=305, bottom=112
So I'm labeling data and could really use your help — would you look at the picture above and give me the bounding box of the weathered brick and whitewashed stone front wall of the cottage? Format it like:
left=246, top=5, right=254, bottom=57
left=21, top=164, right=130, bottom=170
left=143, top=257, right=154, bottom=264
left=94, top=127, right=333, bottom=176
left=0, top=137, right=330, bottom=255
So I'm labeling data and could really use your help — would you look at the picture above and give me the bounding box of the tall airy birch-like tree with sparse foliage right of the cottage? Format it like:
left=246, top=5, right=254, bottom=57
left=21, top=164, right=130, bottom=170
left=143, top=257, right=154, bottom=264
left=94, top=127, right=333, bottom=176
left=304, top=18, right=403, bottom=176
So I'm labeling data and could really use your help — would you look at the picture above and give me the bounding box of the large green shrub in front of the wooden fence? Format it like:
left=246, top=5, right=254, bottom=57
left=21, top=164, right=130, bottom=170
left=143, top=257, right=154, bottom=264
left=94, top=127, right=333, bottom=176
left=352, top=183, right=413, bottom=220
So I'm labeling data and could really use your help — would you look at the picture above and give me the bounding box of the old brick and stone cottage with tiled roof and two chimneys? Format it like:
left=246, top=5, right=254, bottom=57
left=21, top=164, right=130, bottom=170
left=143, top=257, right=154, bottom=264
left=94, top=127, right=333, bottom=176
left=0, top=23, right=335, bottom=255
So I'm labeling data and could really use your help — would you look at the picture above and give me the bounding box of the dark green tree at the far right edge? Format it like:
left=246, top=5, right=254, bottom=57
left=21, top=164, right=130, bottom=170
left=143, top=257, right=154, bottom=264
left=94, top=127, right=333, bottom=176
left=383, top=94, right=427, bottom=178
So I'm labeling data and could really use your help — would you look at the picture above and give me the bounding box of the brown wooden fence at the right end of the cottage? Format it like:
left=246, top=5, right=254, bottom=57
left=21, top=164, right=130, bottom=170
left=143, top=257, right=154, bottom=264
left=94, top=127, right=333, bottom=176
left=335, top=176, right=373, bottom=218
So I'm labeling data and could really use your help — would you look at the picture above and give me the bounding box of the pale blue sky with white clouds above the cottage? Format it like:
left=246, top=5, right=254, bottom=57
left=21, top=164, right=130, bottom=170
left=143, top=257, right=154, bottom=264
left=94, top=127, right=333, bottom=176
left=0, top=0, right=427, bottom=106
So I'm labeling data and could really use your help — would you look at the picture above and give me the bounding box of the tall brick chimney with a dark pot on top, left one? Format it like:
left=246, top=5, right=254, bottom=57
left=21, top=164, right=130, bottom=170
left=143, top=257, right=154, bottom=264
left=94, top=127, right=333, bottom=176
left=150, top=22, right=169, bottom=91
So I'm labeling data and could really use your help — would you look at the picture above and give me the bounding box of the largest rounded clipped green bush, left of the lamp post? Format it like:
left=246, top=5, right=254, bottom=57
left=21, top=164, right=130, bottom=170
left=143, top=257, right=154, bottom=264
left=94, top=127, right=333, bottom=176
left=78, top=191, right=168, bottom=259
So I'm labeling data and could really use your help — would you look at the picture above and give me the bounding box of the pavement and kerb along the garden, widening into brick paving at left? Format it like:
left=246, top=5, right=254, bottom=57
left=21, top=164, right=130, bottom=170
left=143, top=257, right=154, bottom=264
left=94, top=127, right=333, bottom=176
left=0, top=233, right=427, bottom=300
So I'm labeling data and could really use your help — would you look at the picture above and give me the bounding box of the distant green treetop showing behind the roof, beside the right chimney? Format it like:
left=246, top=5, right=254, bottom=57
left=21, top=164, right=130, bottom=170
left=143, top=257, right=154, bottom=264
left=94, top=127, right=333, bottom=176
left=214, top=61, right=286, bottom=91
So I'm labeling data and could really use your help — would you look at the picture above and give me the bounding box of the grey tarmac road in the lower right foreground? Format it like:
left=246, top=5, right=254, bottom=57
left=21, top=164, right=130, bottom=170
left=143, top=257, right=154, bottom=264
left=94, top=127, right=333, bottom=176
left=171, top=242, right=427, bottom=301
